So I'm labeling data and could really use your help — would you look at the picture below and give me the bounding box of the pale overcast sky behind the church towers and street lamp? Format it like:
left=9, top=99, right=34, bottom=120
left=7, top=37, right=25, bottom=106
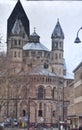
left=0, top=0, right=82, bottom=73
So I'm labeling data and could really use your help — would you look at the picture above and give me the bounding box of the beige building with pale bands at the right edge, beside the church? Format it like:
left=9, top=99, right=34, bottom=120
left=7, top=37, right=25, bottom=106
left=68, top=62, right=82, bottom=127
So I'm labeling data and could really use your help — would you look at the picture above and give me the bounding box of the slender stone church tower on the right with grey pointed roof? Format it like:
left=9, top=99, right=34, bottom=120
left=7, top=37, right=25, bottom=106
left=51, top=19, right=64, bottom=77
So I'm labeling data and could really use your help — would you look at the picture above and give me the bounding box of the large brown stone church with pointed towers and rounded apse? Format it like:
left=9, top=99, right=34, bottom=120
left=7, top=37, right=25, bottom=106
left=1, top=0, right=73, bottom=124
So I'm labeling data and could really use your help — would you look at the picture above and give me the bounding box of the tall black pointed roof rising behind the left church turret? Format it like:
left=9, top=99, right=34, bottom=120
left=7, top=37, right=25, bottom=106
left=7, top=0, right=30, bottom=37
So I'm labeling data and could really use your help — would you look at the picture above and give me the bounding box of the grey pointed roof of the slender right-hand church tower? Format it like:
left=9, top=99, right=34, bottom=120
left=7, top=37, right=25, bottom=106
left=51, top=19, right=64, bottom=39
